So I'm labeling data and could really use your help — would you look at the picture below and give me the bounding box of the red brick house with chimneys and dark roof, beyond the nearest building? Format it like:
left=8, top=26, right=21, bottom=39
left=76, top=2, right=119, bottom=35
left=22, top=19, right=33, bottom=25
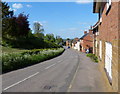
left=80, top=29, right=93, bottom=53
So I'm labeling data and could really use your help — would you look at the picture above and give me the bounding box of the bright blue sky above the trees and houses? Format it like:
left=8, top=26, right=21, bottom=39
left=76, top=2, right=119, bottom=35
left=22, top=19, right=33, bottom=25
left=8, top=2, right=98, bottom=38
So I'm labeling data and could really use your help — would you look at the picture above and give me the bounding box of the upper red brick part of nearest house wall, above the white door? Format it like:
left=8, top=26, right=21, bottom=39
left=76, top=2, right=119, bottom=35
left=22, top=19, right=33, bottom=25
left=99, top=2, right=118, bottom=42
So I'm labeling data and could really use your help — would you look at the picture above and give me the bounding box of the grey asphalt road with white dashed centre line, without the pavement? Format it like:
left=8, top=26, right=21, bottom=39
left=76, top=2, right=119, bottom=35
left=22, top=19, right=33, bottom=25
left=2, top=49, right=79, bottom=92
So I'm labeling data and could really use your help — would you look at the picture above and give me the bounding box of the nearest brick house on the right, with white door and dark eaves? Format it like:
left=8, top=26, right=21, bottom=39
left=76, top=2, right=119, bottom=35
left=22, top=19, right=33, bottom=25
left=93, top=0, right=120, bottom=91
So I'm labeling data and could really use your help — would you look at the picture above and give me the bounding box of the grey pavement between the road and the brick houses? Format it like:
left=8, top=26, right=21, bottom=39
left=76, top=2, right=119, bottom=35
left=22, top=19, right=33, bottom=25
left=68, top=52, right=108, bottom=92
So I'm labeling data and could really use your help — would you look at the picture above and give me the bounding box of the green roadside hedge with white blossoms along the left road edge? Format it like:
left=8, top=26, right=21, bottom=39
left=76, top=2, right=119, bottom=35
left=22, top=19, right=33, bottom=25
left=2, top=48, right=64, bottom=73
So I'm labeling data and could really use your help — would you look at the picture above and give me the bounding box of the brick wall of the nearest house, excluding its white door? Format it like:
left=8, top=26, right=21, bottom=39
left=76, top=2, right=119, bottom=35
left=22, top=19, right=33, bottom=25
left=97, top=2, right=120, bottom=91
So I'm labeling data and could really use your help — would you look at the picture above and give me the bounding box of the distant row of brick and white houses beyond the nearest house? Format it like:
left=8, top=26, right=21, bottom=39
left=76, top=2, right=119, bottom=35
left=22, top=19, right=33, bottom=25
left=66, top=29, right=93, bottom=53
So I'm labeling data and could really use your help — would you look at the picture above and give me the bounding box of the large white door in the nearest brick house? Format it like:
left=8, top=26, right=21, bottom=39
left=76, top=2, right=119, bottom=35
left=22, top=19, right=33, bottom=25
left=105, top=42, right=112, bottom=80
